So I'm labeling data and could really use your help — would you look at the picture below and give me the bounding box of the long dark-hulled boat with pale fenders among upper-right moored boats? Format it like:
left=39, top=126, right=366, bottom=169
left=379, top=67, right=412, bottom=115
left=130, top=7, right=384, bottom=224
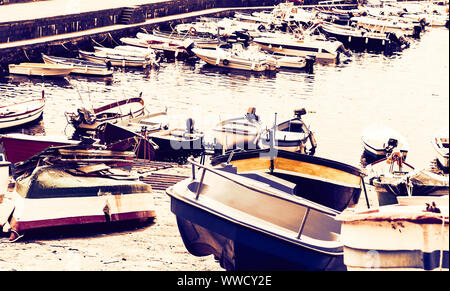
left=320, top=23, right=409, bottom=52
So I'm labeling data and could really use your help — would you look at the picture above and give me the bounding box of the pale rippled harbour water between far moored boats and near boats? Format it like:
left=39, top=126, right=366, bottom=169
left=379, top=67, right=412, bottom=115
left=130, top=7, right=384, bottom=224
left=0, top=28, right=449, bottom=167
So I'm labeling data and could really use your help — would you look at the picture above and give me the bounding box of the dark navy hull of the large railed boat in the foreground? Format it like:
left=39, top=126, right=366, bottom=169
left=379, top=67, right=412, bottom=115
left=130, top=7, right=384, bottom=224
left=171, top=197, right=345, bottom=271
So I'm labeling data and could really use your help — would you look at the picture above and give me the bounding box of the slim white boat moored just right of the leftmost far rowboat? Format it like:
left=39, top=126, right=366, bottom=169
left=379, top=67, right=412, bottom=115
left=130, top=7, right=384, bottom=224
left=42, top=54, right=114, bottom=76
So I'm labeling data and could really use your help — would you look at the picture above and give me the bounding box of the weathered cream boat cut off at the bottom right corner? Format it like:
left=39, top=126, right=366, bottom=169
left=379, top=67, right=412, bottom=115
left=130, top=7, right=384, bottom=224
left=337, top=196, right=449, bottom=271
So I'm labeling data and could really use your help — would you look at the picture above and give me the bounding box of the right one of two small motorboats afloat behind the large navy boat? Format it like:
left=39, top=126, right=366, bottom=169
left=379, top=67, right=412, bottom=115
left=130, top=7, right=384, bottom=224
left=261, top=108, right=317, bottom=155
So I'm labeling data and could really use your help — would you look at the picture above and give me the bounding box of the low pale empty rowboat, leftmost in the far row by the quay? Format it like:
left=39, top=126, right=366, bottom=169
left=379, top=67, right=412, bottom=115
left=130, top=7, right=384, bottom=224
left=8, top=63, right=73, bottom=78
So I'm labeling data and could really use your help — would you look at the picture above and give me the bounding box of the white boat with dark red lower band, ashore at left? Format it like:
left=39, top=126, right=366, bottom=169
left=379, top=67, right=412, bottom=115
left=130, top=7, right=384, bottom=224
left=0, top=148, right=155, bottom=241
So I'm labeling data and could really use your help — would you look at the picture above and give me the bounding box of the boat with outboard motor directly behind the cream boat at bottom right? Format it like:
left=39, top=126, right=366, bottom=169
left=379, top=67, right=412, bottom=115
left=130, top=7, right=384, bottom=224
left=367, top=152, right=449, bottom=205
